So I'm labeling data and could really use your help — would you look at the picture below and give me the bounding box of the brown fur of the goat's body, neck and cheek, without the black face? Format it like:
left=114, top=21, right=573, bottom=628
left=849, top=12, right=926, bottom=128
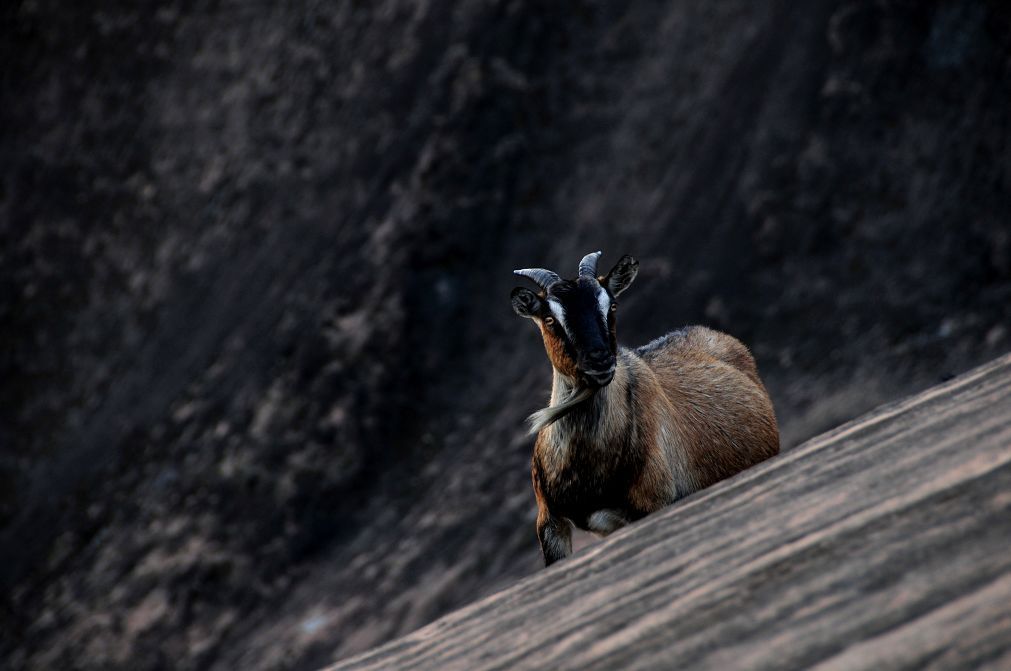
left=532, top=326, right=779, bottom=564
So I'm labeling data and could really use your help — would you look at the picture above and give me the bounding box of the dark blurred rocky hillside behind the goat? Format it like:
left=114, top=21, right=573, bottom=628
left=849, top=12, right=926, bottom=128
left=0, top=0, right=1011, bottom=669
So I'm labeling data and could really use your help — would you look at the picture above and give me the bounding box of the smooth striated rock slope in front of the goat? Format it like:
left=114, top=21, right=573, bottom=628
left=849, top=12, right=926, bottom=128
left=330, top=356, right=1011, bottom=671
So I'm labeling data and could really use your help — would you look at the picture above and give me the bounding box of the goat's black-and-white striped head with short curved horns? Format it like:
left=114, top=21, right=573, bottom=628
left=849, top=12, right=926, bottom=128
left=513, top=252, right=639, bottom=389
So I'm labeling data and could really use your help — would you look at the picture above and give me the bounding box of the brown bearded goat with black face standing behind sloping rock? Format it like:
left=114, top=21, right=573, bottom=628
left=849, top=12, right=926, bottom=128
left=511, top=252, right=779, bottom=566
